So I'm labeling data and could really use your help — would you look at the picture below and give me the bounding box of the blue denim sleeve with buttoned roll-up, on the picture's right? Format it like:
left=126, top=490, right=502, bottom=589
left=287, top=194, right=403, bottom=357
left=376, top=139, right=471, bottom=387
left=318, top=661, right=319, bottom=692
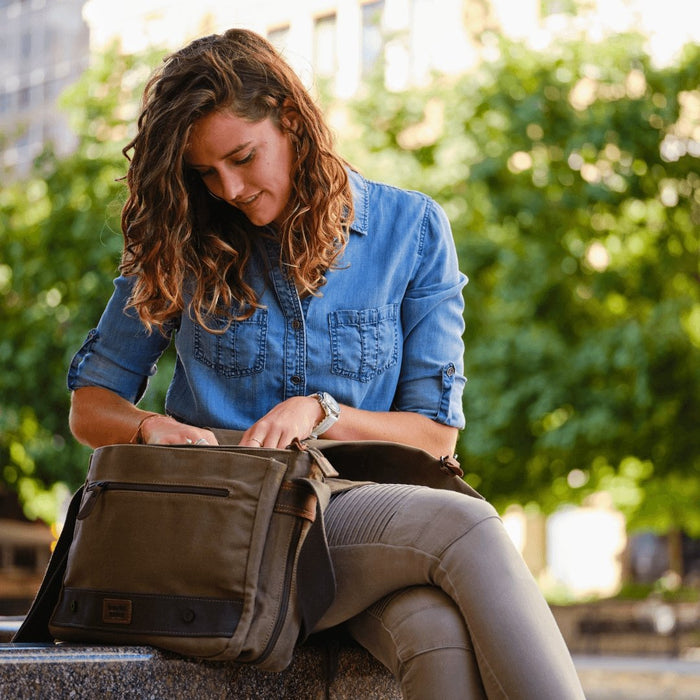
left=395, top=200, right=467, bottom=429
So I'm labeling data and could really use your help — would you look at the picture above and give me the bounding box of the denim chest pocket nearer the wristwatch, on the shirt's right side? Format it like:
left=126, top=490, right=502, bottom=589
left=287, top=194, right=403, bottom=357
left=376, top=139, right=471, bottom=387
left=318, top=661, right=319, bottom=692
left=328, top=304, right=399, bottom=382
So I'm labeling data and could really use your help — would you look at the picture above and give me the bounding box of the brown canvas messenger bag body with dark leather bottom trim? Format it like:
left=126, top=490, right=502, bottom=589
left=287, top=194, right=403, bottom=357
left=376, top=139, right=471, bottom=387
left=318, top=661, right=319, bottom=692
left=49, top=445, right=335, bottom=671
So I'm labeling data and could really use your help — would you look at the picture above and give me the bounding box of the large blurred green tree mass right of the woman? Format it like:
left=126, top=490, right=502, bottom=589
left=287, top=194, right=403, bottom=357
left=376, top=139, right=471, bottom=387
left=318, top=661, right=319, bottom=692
left=344, top=31, right=700, bottom=535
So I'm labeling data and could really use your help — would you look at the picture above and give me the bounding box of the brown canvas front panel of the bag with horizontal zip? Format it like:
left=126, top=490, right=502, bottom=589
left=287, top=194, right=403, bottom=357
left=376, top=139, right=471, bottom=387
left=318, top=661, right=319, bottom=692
left=65, top=460, right=285, bottom=601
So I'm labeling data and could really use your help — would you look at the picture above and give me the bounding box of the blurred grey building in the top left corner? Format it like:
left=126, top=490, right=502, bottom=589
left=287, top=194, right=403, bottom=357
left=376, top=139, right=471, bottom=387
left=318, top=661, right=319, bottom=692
left=0, top=0, right=90, bottom=175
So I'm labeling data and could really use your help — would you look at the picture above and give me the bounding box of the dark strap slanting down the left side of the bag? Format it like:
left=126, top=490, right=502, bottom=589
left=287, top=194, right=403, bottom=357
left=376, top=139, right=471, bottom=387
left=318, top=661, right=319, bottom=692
left=12, top=486, right=84, bottom=644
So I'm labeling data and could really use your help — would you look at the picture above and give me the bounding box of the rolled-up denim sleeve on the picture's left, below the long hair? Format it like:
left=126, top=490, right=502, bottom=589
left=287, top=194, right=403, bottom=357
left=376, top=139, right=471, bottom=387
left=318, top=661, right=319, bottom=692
left=68, top=277, right=170, bottom=403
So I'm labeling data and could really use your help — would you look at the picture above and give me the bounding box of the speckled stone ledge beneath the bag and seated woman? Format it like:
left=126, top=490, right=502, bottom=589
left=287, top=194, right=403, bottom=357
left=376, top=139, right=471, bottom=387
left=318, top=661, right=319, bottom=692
left=0, top=641, right=401, bottom=700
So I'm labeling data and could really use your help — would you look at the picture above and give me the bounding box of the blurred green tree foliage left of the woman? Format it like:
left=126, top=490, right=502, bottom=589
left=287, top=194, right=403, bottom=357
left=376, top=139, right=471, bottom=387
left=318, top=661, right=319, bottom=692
left=0, top=46, right=167, bottom=522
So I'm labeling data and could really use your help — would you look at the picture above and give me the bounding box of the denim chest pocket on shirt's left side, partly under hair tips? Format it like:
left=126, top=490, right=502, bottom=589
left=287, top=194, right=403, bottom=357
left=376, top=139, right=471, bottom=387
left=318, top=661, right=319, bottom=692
left=193, top=309, right=267, bottom=377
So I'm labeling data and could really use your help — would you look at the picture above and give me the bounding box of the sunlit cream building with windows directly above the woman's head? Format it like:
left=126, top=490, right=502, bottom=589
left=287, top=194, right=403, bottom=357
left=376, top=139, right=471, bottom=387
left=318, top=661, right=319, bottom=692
left=85, top=0, right=476, bottom=96
